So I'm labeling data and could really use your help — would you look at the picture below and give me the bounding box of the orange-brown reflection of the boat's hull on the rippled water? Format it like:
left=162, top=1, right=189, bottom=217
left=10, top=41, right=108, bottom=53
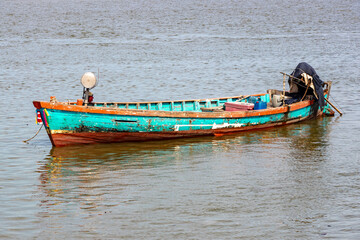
left=39, top=117, right=331, bottom=192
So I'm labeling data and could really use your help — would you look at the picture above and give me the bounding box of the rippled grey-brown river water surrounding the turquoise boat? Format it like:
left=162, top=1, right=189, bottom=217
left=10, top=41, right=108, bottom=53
left=0, top=0, right=360, bottom=239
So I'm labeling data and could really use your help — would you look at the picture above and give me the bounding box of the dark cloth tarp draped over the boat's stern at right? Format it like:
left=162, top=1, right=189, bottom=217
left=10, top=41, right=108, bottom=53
left=288, top=62, right=325, bottom=108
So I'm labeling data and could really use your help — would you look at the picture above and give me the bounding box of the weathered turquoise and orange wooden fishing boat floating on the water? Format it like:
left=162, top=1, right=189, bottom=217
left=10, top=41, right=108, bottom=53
left=33, top=63, right=334, bottom=146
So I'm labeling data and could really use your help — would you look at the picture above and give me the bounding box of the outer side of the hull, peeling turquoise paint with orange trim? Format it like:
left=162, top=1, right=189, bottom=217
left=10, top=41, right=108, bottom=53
left=34, top=94, right=330, bottom=146
